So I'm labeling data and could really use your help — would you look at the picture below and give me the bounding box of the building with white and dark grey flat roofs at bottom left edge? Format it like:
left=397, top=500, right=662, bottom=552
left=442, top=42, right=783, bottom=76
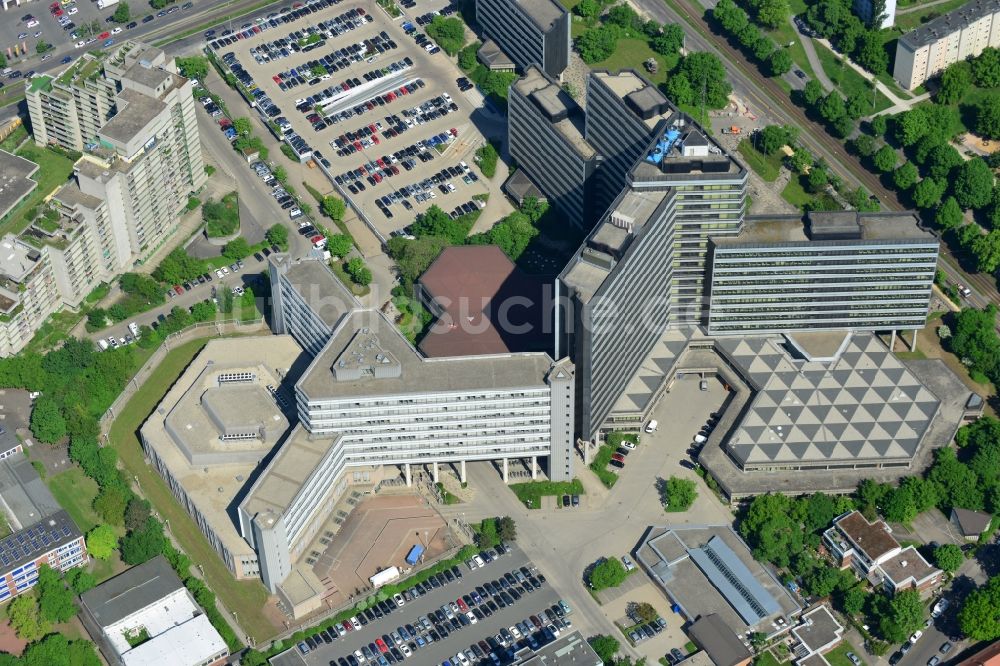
left=80, top=555, right=229, bottom=666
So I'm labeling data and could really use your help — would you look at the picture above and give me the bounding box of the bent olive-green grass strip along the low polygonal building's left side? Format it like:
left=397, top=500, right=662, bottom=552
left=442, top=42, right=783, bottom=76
left=108, top=339, right=279, bottom=641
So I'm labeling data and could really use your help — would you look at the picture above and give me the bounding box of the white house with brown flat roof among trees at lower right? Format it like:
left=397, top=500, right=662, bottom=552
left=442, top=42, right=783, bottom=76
left=823, top=511, right=942, bottom=596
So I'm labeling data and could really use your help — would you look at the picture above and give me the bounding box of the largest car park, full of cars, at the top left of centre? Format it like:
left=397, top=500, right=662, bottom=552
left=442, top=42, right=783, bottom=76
left=209, top=0, right=500, bottom=238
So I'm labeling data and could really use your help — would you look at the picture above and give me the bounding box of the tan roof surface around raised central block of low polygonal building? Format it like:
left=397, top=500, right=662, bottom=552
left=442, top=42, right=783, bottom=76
left=141, top=335, right=308, bottom=553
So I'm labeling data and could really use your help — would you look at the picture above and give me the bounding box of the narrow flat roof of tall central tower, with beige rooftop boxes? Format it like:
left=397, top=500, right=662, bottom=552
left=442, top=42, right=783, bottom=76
left=559, top=188, right=673, bottom=303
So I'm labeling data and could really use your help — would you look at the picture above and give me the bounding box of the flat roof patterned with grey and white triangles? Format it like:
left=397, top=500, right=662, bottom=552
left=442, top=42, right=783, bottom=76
left=718, top=333, right=940, bottom=466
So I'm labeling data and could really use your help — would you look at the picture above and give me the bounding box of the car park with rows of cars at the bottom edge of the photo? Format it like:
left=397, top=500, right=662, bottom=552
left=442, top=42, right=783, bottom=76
left=281, top=546, right=572, bottom=666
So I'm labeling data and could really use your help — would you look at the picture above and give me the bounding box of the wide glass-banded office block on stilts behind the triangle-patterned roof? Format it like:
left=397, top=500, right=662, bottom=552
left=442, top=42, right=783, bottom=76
left=708, top=212, right=938, bottom=339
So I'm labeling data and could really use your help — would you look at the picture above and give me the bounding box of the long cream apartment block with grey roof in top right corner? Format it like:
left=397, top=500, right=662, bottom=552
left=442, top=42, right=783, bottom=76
left=893, top=0, right=1000, bottom=90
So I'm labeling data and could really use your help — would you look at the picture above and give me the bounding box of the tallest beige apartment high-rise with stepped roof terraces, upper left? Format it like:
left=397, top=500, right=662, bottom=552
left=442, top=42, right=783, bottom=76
left=26, top=41, right=206, bottom=266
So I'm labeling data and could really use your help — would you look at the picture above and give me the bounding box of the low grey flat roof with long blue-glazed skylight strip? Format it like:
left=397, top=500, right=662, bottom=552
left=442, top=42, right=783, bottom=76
left=635, top=525, right=799, bottom=634
